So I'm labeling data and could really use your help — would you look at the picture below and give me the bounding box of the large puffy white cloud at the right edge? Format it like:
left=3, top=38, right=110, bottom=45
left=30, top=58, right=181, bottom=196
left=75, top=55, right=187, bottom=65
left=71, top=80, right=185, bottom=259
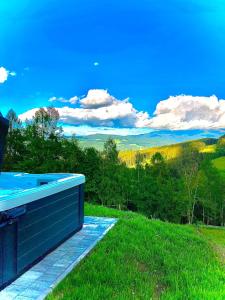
left=148, top=95, right=225, bottom=130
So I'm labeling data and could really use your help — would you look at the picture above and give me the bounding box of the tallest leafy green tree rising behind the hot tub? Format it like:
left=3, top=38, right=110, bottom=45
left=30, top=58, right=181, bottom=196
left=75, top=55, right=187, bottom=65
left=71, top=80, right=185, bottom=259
left=20, top=107, right=62, bottom=173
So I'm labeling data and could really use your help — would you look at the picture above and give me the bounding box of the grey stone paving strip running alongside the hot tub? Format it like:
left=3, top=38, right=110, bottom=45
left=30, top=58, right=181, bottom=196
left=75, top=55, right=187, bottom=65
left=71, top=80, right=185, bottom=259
left=0, top=217, right=117, bottom=300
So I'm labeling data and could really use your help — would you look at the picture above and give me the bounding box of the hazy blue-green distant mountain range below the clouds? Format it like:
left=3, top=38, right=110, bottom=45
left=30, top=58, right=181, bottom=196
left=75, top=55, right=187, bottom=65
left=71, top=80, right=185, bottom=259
left=77, top=130, right=225, bottom=150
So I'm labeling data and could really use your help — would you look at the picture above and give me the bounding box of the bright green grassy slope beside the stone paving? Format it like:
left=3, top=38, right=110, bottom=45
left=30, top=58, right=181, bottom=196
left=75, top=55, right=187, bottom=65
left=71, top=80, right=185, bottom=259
left=47, top=205, right=225, bottom=300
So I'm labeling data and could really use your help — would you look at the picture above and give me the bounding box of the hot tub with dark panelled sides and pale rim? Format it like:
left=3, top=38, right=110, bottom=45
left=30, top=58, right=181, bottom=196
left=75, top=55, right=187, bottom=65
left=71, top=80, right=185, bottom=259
left=0, top=173, right=85, bottom=289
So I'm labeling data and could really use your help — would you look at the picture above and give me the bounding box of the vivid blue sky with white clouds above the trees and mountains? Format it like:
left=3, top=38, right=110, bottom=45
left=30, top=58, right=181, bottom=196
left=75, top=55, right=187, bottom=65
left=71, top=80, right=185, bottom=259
left=0, top=0, right=225, bottom=134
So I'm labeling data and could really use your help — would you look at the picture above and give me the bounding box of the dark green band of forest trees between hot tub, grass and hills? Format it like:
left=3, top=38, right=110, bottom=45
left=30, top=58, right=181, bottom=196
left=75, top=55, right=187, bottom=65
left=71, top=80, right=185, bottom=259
left=4, top=107, right=225, bottom=226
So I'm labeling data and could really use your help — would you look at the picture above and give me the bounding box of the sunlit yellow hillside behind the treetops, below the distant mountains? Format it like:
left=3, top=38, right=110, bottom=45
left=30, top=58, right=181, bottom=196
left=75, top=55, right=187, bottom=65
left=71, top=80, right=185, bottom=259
left=119, top=138, right=217, bottom=166
